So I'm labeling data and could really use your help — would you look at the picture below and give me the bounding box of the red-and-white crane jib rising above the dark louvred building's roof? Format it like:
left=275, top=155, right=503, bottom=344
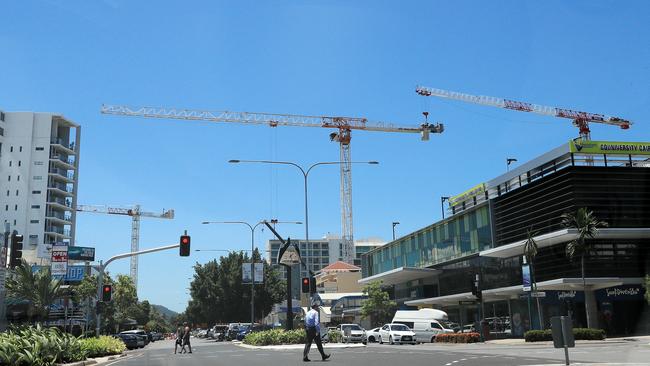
left=415, top=86, right=632, bottom=140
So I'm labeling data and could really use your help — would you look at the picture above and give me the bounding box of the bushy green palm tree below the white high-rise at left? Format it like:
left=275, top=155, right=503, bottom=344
left=6, top=259, right=64, bottom=320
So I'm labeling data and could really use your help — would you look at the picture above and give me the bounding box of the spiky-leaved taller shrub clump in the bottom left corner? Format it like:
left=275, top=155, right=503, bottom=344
left=0, top=325, right=86, bottom=366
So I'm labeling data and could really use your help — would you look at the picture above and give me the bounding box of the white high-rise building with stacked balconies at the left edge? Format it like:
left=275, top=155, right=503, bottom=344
left=0, top=111, right=81, bottom=264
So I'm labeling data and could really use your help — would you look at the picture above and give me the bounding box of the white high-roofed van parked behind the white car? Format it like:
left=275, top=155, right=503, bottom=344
left=392, top=309, right=454, bottom=342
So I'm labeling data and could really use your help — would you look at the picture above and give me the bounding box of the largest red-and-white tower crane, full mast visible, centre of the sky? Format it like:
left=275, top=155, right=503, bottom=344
left=101, top=105, right=444, bottom=263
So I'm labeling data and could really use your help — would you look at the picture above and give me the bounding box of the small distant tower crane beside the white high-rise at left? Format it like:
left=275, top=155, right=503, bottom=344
left=76, top=205, right=174, bottom=292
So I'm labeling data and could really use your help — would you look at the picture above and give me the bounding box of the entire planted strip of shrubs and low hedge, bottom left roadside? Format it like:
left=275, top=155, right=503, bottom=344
left=0, top=325, right=126, bottom=366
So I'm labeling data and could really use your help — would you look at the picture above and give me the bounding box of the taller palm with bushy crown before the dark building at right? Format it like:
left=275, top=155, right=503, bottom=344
left=562, top=207, right=607, bottom=328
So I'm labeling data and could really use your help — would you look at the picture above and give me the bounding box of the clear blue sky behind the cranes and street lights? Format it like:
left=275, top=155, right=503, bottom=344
left=0, top=0, right=650, bottom=311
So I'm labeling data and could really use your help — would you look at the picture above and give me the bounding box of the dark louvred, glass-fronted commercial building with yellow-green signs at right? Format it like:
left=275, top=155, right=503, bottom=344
left=359, top=140, right=650, bottom=336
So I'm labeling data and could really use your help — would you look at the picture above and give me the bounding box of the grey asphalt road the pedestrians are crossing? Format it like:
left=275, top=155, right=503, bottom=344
left=107, top=339, right=650, bottom=366
